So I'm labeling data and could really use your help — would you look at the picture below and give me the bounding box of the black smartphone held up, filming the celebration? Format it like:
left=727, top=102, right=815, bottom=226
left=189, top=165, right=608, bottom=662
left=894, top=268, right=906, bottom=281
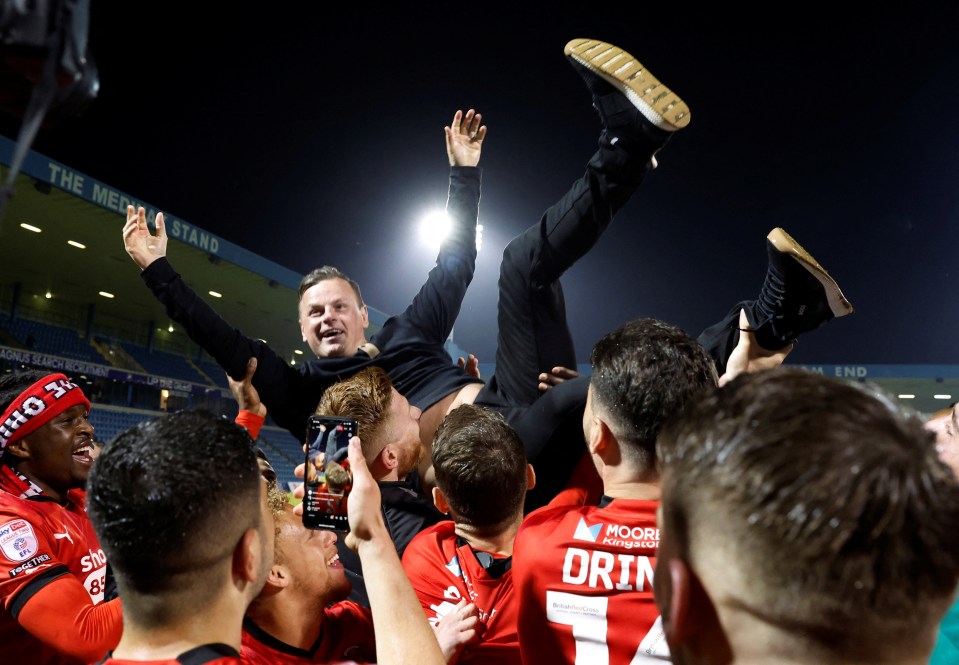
left=303, top=416, right=356, bottom=532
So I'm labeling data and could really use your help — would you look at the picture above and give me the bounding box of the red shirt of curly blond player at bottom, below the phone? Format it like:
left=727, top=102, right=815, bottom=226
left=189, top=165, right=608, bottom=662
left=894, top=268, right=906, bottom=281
left=240, top=600, right=376, bottom=665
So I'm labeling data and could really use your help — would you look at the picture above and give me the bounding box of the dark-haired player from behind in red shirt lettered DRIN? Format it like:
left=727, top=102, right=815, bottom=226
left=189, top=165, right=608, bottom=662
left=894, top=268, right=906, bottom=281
left=513, top=319, right=716, bottom=665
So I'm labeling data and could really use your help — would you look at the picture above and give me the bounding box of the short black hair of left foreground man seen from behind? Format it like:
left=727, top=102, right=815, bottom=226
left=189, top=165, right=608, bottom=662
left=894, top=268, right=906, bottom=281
left=87, top=410, right=262, bottom=612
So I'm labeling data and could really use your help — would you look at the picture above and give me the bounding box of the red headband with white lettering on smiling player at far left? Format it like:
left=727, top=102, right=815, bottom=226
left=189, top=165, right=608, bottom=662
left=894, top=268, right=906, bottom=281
left=0, top=374, right=90, bottom=450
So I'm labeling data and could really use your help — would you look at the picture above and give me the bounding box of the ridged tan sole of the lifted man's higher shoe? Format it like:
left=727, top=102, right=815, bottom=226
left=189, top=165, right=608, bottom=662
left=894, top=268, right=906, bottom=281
left=563, top=38, right=689, bottom=132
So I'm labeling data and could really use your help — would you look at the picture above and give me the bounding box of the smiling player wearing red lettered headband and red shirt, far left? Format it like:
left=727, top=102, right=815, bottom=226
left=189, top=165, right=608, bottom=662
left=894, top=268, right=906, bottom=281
left=0, top=371, right=122, bottom=665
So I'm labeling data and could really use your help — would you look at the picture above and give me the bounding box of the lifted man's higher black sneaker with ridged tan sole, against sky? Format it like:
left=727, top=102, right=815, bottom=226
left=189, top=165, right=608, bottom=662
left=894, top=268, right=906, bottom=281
left=563, top=39, right=690, bottom=140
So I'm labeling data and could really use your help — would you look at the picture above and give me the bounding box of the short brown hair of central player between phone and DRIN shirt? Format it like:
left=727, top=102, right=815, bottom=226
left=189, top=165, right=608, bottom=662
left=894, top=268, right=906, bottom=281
left=433, top=404, right=526, bottom=527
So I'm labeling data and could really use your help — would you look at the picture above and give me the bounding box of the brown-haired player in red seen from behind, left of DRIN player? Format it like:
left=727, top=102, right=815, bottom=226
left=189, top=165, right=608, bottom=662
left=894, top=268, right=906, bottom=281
left=403, top=404, right=535, bottom=664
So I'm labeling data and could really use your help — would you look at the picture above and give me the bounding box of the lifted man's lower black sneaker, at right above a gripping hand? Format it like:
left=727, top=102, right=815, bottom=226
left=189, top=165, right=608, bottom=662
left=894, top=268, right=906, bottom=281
left=747, top=228, right=853, bottom=351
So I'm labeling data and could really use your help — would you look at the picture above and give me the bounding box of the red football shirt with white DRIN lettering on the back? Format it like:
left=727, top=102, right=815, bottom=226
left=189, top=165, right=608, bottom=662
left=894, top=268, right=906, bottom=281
left=513, top=499, right=669, bottom=665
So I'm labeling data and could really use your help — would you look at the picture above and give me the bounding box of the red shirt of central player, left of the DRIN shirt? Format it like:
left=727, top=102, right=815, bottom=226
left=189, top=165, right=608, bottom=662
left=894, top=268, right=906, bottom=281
left=403, top=521, right=521, bottom=663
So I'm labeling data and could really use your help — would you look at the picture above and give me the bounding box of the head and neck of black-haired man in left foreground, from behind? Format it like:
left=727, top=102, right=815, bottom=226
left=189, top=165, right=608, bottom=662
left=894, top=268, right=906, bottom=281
left=88, top=410, right=274, bottom=665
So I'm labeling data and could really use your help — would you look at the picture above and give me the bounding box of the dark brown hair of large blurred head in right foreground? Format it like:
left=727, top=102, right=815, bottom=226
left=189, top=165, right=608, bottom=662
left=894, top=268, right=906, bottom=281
left=657, top=368, right=959, bottom=662
